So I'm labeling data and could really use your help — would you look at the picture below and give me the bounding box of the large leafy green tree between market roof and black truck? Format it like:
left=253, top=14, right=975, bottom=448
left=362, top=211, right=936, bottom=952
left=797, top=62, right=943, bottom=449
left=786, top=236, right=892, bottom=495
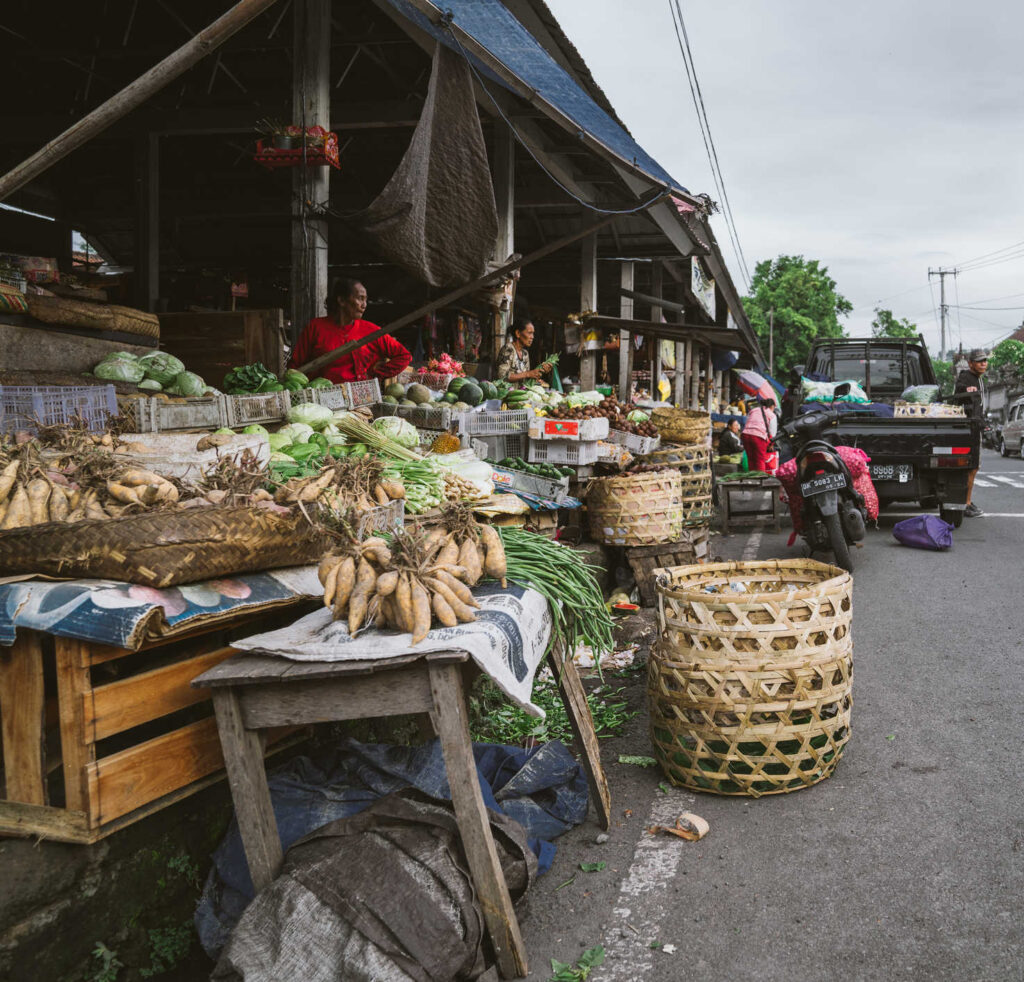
left=743, top=256, right=853, bottom=378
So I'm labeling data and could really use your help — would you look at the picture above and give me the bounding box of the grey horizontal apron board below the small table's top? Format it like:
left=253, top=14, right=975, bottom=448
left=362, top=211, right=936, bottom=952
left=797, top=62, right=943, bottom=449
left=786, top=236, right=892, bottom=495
left=240, top=666, right=433, bottom=729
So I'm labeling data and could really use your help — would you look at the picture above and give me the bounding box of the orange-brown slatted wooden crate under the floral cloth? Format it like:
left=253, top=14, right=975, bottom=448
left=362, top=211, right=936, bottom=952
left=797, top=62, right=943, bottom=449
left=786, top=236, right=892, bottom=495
left=0, top=605, right=305, bottom=843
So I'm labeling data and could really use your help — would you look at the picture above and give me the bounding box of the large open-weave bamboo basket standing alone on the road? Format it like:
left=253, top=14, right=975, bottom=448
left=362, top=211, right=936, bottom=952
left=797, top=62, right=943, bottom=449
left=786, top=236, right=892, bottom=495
left=647, top=559, right=853, bottom=798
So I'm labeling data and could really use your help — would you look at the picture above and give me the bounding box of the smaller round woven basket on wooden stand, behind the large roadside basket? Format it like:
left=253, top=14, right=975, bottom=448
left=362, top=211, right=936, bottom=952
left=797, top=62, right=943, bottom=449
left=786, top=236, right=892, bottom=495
left=587, top=470, right=683, bottom=546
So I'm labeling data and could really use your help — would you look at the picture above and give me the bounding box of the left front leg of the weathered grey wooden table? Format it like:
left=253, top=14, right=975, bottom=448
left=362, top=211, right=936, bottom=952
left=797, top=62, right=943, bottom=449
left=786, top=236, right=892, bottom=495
left=213, top=689, right=284, bottom=893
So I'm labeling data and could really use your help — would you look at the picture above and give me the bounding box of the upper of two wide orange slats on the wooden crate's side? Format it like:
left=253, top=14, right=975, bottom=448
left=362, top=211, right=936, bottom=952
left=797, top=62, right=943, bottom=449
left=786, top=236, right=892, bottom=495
left=86, top=647, right=234, bottom=740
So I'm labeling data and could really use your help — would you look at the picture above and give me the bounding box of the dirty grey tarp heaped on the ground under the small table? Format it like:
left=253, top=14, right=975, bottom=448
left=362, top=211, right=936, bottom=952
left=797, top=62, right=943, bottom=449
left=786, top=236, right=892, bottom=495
left=213, top=791, right=537, bottom=982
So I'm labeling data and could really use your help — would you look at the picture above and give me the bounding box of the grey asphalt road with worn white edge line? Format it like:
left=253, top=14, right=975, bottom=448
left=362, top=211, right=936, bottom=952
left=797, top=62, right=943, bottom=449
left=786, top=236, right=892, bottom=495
left=522, top=451, right=1024, bottom=982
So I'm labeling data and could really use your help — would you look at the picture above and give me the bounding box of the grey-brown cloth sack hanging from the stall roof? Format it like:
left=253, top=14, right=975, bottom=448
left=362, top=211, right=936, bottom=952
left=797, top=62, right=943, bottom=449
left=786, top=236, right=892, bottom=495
left=352, top=45, right=505, bottom=287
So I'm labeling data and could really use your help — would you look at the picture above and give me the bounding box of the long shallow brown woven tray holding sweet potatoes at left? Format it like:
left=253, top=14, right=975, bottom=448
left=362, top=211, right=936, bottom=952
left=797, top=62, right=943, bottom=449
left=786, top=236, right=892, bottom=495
left=0, top=508, right=329, bottom=588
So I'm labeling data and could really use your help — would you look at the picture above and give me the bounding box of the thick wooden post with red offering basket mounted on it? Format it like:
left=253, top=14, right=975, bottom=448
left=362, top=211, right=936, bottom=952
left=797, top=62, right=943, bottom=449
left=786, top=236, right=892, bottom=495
left=291, top=0, right=332, bottom=342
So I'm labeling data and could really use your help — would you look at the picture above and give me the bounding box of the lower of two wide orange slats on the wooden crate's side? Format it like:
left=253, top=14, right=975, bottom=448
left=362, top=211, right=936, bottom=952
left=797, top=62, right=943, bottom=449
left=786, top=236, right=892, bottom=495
left=86, top=718, right=224, bottom=825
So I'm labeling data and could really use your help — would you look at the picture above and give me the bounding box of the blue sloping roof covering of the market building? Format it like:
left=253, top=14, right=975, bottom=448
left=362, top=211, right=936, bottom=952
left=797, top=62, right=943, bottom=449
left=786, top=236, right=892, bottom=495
left=386, top=0, right=686, bottom=193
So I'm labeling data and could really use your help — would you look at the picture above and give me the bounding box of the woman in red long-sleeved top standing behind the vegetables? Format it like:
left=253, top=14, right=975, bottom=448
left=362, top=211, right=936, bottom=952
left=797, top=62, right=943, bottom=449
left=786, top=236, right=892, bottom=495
left=289, top=279, right=413, bottom=384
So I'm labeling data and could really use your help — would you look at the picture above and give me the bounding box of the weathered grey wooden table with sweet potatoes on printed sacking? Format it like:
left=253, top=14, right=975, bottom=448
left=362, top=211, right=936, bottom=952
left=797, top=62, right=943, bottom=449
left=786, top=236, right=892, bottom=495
left=193, top=651, right=610, bottom=978
